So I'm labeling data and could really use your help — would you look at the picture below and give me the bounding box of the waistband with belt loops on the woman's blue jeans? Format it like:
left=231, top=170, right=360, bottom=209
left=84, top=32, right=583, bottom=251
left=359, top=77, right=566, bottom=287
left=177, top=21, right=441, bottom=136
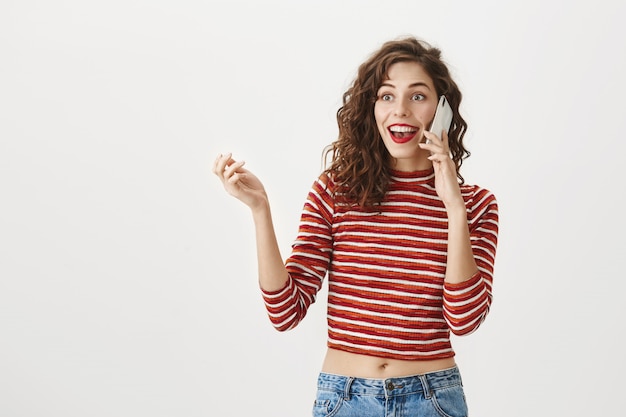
left=317, top=366, right=462, bottom=398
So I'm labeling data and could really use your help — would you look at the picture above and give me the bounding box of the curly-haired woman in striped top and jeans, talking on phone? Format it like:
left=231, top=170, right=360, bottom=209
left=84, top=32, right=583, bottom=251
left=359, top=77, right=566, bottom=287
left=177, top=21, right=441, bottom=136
left=213, top=38, right=498, bottom=417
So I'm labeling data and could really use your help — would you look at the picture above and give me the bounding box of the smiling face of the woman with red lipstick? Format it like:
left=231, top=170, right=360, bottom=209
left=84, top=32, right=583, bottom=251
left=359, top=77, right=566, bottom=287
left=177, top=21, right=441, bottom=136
left=374, top=62, right=439, bottom=171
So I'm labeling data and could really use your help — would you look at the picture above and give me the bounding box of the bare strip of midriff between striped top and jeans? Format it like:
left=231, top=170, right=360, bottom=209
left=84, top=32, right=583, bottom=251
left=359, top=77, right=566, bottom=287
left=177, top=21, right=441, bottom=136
left=322, top=348, right=455, bottom=379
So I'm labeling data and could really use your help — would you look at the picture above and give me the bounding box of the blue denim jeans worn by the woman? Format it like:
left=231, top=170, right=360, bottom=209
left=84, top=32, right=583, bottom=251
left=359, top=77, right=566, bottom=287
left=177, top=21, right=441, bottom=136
left=313, top=367, right=467, bottom=417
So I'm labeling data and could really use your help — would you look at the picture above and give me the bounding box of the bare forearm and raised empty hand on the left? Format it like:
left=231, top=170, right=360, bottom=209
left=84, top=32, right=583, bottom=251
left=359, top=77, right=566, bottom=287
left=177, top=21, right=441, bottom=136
left=213, top=154, right=289, bottom=292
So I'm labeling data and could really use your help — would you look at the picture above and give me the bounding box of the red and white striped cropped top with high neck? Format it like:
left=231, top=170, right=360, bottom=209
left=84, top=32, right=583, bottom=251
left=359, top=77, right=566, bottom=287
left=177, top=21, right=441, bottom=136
left=262, top=170, right=498, bottom=360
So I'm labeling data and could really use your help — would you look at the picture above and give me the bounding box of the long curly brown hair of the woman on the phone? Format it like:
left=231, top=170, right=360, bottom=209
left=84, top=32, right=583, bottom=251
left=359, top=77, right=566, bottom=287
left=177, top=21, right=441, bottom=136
left=324, top=37, right=470, bottom=207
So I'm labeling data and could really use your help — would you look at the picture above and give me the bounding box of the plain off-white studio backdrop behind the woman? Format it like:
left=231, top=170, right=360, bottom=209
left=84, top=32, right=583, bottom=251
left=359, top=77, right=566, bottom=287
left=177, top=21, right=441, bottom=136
left=0, top=0, right=626, bottom=417
